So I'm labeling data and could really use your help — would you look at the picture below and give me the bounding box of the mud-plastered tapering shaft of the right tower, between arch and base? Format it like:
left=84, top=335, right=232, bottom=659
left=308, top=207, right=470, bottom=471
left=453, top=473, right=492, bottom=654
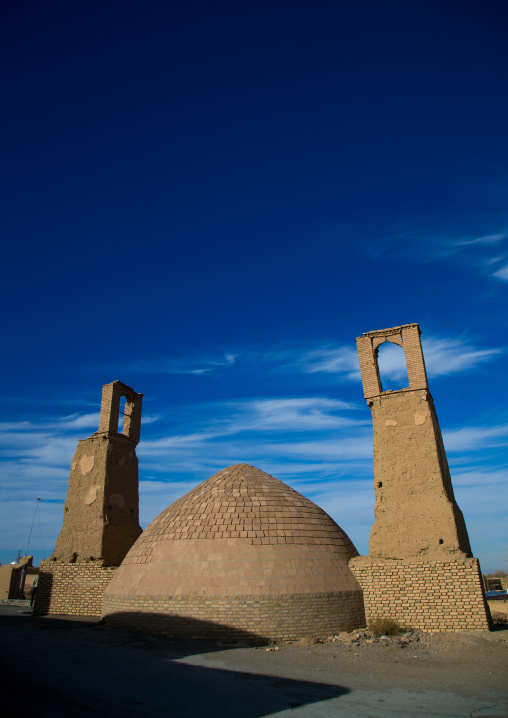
left=368, top=390, right=471, bottom=560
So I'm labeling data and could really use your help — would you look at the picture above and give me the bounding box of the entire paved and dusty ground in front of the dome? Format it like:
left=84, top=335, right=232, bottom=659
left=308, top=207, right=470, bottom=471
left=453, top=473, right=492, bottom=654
left=0, top=606, right=508, bottom=718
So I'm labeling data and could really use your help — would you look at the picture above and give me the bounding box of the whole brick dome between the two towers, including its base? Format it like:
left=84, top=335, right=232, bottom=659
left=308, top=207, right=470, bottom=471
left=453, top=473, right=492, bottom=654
left=103, top=464, right=365, bottom=639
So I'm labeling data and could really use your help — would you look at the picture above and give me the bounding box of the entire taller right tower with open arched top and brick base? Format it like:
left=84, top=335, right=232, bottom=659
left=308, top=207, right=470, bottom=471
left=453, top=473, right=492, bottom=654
left=352, top=324, right=488, bottom=630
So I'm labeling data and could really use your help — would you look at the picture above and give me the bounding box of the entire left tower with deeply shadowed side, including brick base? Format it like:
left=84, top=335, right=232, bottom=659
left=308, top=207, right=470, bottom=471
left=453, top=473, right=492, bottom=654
left=36, top=381, right=143, bottom=615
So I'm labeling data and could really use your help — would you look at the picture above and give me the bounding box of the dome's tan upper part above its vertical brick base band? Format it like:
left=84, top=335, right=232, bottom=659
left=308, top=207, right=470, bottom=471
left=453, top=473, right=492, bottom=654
left=106, top=464, right=359, bottom=596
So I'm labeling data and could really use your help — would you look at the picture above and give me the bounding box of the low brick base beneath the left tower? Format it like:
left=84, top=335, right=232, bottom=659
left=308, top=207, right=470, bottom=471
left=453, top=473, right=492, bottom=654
left=33, top=561, right=116, bottom=616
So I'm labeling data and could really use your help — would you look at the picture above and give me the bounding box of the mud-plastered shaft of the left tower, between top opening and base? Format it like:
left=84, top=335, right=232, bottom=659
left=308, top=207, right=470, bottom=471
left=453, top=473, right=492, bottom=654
left=53, top=433, right=141, bottom=566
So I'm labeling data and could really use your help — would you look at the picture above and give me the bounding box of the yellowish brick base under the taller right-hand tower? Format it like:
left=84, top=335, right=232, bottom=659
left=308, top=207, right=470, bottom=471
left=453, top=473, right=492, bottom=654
left=349, top=556, right=490, bottom=631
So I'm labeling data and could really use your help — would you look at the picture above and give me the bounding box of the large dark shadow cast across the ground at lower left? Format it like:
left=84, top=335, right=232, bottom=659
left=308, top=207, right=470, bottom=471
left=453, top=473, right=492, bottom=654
left=0, top=612, right=348, bottom=718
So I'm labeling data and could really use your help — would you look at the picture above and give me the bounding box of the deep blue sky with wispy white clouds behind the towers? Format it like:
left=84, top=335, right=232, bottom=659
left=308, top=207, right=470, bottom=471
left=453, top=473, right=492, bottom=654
left=0, top=0, right=508, bottom=571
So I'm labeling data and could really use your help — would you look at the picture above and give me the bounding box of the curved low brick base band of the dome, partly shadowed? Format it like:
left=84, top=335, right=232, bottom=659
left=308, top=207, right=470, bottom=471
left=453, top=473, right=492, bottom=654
left=102, top=591, right=365, bottom=642
